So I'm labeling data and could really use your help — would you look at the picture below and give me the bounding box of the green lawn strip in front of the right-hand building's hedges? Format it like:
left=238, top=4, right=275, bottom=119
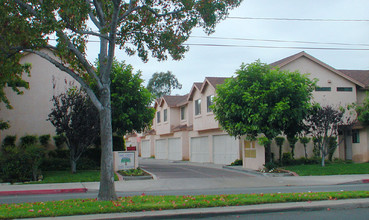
left=283, top=163, right=369, bottom=176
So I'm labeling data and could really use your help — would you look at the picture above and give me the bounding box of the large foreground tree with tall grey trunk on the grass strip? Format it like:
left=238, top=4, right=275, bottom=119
left=0, top=0, right=241, bottom=200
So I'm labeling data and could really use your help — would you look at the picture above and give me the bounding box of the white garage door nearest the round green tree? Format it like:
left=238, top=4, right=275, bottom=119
left=213, top=135, right=240, bottom=164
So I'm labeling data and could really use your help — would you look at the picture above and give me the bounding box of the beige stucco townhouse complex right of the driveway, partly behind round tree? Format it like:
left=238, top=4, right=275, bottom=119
left=133, top=52, right=369, bottom=169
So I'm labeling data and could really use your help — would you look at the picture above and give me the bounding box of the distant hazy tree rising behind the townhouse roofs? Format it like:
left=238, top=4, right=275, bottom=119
left=147, top=71, right=182, bottom=98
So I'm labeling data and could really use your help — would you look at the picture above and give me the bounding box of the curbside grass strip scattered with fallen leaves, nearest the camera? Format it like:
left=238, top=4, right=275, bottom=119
left=0, top=191, right=369, bottom=219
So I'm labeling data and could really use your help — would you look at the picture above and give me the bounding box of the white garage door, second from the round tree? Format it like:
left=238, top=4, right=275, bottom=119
left=190, top=137, right=210, bottom=163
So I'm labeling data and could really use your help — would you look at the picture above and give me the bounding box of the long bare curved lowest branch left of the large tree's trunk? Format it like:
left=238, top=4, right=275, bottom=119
left=24, top=49, right=103, bottom=111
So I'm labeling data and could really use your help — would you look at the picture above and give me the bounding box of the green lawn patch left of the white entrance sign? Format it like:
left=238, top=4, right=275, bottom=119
left=27, top=170, right=118, bottom=184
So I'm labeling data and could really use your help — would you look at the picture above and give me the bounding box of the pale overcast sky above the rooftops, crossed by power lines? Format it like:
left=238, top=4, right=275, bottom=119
left=88, top=0, right=369, bottom=95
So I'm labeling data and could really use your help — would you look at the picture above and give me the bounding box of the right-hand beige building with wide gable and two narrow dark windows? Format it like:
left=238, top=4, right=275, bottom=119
left=270, top=52, right=369, bottom=162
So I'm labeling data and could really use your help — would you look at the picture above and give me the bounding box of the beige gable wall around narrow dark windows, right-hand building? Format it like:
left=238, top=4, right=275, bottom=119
left=281, top=57, right=357, bottom=106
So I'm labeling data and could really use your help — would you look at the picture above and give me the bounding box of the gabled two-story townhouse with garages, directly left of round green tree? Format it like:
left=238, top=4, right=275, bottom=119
left=188, top=77, right=242, bottom=164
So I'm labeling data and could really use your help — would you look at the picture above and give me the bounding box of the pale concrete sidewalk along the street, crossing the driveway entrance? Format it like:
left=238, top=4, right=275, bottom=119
left=0, top=160, right=369, bottom=196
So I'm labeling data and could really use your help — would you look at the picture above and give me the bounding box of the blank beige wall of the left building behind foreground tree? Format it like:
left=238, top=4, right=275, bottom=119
left=0, top=50, right=75, bottom=144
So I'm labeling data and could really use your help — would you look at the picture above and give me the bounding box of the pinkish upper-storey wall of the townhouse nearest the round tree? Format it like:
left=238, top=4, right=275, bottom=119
left=192, top=86, right=219, bottom=131
